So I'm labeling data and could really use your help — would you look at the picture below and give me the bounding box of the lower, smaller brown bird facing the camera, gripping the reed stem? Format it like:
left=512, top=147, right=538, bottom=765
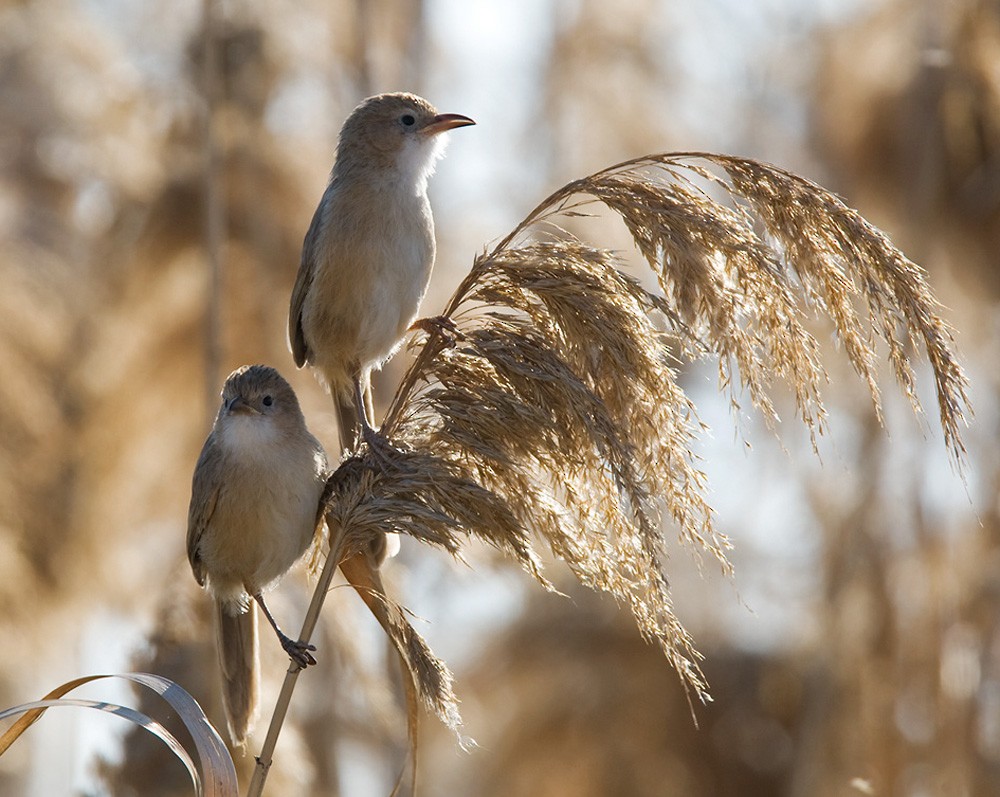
left=187, top=365, right=328, bottom=746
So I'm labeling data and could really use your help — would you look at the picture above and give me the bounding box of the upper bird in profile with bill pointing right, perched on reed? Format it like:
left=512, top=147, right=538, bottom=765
left=288, top=92, right=475, bottom=455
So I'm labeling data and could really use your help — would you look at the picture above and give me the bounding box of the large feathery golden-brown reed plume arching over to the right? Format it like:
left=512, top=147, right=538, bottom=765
left=322, top=153, right=969, bottom=716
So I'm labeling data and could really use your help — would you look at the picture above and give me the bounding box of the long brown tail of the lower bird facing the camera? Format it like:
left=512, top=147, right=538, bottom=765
left=215, top=601, right=260, bottom=747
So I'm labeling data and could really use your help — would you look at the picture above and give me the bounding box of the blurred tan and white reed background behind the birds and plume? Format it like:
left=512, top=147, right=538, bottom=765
left=0, top=0, right=1000, bottom=797
